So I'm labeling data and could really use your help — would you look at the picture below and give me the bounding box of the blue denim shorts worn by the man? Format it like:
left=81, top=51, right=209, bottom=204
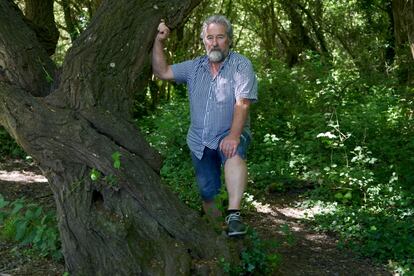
left=191, top=132, right=251, bottom=201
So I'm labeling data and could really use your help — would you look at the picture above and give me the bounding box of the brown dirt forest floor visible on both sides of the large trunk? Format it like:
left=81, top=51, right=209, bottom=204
left=0, top=160, right=392, bottom=276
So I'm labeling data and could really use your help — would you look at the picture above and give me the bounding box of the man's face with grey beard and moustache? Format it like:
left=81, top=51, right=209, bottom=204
left=203, top=23, right=231, bottom=63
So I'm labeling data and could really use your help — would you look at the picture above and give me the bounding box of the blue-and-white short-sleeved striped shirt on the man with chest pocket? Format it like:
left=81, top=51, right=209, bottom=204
left=172, top=51, right=257, bottom=159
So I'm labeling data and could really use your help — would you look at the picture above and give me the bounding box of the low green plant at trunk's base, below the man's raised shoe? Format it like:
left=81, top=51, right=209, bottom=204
left=220, top=230, right=280, bottom=276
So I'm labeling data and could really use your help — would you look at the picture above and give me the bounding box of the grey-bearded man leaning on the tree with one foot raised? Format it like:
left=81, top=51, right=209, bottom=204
left=152, top=15, right=257, bottom=237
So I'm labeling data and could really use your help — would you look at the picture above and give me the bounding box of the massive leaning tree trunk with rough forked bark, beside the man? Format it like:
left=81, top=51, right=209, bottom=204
left=0, top=0, right=238, bottom=275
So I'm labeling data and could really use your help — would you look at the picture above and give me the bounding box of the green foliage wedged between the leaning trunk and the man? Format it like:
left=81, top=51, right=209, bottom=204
left=137, top=98, right=200, bottom=210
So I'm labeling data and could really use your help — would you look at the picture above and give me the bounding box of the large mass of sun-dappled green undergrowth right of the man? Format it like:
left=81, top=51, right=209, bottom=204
left=249, top=53, right=414, bottom=272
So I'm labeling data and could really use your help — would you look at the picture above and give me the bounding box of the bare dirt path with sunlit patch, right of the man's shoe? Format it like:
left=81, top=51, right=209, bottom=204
left=244, top=194, right=392, bottom=276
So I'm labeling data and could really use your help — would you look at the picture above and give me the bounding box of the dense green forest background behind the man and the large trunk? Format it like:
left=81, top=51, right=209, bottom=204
left=0, top=0, right=414, bottom=274
